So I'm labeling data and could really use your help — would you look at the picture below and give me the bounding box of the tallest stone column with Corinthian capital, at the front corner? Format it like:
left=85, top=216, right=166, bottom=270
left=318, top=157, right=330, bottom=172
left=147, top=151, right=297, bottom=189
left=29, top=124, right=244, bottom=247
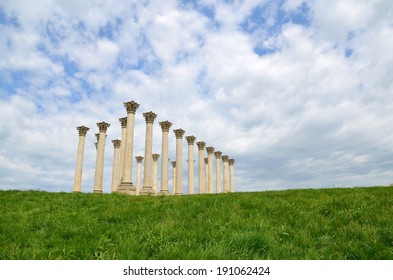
left=118, top=101, right=139, bottom=194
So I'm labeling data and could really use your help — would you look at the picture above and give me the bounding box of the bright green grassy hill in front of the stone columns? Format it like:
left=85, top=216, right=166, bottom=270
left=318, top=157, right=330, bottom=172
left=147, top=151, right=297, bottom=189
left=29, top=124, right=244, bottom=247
left=0, top=187, right=393, bottom=259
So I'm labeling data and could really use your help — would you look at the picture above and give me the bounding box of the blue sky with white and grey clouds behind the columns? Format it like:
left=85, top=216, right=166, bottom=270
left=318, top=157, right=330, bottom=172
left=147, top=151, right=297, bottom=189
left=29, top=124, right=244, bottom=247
left=0, top=0, right=393, bottom=193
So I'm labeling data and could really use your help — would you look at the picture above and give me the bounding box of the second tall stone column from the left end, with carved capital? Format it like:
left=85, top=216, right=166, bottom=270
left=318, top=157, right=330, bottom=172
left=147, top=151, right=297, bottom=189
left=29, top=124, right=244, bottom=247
left=94, top=122, right=110, bottom=193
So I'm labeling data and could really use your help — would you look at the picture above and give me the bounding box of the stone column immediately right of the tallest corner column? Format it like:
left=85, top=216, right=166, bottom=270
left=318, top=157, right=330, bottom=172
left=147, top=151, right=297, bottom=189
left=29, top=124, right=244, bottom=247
left=141, top=112, right=157, bottom=194
